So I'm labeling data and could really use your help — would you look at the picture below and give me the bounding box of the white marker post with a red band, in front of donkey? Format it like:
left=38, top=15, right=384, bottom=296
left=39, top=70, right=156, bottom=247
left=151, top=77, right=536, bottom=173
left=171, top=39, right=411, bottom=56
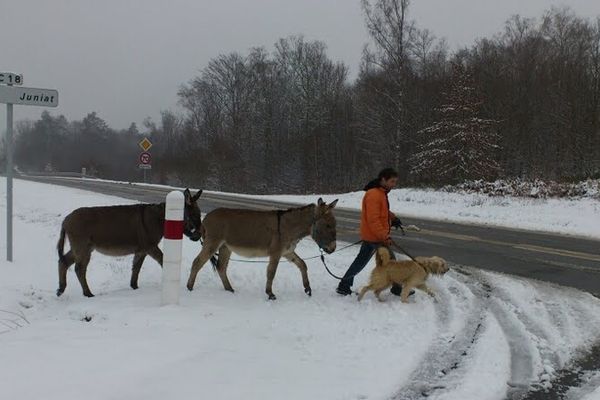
left=162, top=191, right=184, bottom=305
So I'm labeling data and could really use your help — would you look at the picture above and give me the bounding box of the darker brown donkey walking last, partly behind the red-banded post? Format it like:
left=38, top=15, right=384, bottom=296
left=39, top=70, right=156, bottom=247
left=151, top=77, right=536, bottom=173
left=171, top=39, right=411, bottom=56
left=56, top=189, right=202, bottom=297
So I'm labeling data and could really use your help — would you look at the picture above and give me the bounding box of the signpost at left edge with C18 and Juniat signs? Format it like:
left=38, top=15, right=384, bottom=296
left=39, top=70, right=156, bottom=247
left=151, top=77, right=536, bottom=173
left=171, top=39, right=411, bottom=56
left=0, top=72, right=58, bottom=261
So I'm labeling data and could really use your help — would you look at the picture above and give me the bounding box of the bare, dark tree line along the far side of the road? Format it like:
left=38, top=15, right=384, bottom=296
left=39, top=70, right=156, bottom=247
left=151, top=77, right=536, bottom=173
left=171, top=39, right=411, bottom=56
left=9, top=0, right=600, bottom=193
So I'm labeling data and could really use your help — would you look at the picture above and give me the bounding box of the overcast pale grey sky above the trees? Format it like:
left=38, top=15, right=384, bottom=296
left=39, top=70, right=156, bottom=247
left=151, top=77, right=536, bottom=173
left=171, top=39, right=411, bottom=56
left=0, top=0, right=600, bottom=131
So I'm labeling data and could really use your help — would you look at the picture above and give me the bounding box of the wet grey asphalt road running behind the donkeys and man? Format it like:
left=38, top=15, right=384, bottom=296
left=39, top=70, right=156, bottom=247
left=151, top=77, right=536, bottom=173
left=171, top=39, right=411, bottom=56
left=22, top=176, right=600, bottom=297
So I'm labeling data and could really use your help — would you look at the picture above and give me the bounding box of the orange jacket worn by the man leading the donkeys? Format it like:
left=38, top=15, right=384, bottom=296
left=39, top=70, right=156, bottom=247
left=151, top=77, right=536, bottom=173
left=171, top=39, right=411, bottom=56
left=360, top=187, right=394, bottom=242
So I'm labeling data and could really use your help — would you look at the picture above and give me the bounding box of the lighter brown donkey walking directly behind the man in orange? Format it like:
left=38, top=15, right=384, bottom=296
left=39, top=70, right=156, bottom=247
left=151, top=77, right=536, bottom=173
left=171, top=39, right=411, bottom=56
left=187, top=199, right=337, bottom=300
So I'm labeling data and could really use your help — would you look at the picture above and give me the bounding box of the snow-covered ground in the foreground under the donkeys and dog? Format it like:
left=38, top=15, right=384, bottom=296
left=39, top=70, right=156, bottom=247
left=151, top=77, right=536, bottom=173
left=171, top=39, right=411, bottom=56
left=0, top=180, right=600, bottom=400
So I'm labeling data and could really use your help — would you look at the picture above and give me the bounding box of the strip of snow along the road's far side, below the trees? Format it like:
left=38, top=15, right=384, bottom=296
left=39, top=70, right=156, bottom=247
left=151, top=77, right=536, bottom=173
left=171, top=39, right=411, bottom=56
left=231, top=188, right=600, bottom=238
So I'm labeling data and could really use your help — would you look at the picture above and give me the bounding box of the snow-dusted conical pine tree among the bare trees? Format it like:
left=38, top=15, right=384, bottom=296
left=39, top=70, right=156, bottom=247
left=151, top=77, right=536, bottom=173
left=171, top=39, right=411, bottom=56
left=410, top=64, right=501, bottom=183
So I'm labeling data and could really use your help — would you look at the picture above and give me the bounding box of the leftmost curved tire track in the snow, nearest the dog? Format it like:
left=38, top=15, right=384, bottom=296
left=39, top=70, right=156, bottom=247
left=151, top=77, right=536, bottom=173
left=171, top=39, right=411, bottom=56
left=391, top=268, right=486, bottom=400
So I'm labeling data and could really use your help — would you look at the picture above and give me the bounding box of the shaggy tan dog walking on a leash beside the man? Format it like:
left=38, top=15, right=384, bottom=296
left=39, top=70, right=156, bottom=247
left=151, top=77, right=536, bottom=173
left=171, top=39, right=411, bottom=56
left=358, top=247, right=448, bottom=303
